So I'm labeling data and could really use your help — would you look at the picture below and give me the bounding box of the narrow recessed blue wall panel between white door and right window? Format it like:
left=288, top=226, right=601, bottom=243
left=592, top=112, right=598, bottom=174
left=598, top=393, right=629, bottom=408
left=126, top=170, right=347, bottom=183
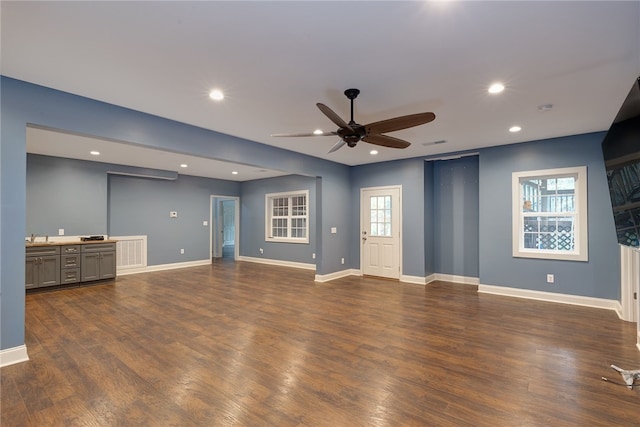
left=433, top=156, right=480, bottom=277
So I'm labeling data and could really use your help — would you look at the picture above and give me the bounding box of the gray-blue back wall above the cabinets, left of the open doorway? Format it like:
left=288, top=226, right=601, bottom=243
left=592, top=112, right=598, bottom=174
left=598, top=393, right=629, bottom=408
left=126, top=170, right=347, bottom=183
left=26, top=154, right=240, bottom=266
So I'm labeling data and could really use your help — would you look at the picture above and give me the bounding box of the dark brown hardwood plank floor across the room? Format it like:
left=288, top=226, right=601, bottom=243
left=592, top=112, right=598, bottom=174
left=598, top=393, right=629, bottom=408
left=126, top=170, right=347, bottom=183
left=0, top=261, right=640, bottom=427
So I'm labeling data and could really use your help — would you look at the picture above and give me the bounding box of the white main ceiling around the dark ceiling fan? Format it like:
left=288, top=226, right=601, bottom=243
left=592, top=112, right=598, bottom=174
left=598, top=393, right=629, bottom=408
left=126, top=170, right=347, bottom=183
left=0, top=1, right=640, bottom=176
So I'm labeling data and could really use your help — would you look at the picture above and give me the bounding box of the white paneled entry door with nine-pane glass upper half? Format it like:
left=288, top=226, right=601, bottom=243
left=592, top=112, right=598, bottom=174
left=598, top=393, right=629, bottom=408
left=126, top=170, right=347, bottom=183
left=360, top=187, right=402, bottom=279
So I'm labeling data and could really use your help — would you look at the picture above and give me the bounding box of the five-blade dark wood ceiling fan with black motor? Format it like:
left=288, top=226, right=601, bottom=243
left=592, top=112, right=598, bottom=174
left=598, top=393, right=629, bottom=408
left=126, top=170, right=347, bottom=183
left=271, top=89, right=436, bottom=153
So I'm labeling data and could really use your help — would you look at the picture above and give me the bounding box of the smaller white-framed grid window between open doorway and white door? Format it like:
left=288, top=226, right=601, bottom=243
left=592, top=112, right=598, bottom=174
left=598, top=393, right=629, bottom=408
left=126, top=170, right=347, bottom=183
left=265, top=190, right=309, bottom=243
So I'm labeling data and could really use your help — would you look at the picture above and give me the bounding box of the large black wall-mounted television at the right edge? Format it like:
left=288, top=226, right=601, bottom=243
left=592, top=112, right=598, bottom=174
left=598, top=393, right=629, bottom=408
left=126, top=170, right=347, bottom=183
left=602, top=77, right=640, bottom=247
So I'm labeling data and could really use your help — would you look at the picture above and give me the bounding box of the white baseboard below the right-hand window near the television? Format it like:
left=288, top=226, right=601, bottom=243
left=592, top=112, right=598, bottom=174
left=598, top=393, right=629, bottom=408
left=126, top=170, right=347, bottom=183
left=478, top=285, right=622, bottom=316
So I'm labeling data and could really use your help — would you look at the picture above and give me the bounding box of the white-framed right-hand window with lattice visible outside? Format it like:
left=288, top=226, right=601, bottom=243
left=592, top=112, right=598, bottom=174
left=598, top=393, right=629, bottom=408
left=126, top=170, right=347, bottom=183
left=512, top=166, right=588, bottom=261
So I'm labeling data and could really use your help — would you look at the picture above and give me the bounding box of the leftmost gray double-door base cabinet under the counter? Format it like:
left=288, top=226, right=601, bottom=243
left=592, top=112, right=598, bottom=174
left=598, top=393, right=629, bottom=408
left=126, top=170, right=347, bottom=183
left=25, top=245, right=60, bottom=289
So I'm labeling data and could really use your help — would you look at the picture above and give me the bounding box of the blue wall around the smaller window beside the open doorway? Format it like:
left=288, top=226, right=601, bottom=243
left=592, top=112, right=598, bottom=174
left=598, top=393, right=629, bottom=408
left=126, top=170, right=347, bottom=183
left=240, top=175, right=317, bottom=264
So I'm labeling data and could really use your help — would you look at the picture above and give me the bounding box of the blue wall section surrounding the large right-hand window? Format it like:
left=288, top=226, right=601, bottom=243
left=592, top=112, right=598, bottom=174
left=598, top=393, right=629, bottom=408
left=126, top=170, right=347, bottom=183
left=479, top=132, right=620, bottom=300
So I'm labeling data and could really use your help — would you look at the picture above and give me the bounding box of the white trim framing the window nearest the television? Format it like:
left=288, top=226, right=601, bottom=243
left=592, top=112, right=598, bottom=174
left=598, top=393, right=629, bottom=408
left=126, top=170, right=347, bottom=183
left=511, top=166, right=589, bottom=261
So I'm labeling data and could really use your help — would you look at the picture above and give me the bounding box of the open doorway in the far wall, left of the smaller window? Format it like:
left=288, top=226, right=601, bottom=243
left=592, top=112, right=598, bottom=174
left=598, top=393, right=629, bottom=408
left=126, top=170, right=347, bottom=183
left=209, top=196, right=240, bottom=261
